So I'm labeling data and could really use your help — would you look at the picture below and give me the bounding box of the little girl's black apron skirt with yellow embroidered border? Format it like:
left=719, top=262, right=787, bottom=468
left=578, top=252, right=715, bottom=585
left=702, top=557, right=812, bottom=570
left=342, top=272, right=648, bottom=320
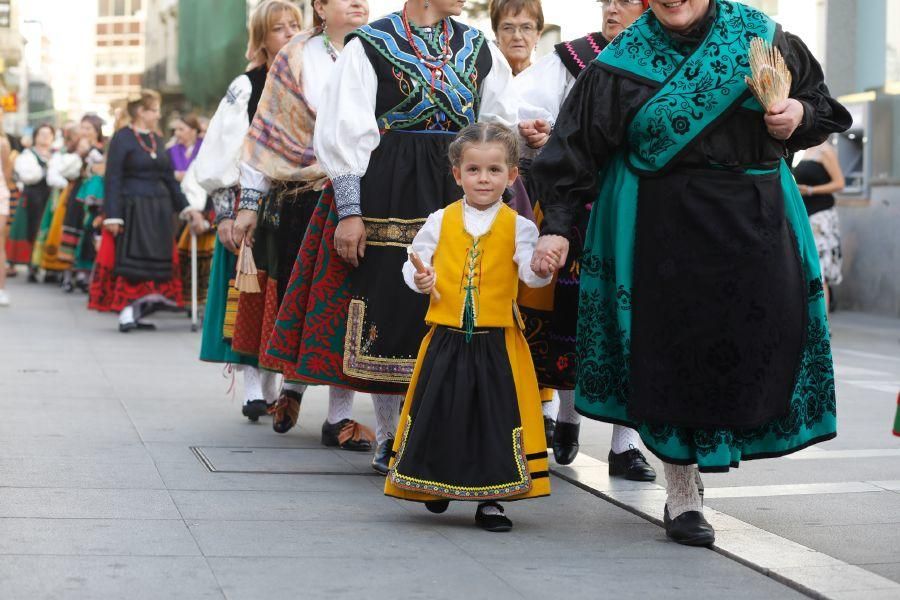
left=390, top=327, right=531, bottom=500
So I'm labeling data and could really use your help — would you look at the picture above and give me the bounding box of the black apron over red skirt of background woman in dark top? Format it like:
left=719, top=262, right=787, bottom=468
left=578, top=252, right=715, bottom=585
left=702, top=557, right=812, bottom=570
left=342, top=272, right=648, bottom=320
left=113, top=195, right=175, bottom=282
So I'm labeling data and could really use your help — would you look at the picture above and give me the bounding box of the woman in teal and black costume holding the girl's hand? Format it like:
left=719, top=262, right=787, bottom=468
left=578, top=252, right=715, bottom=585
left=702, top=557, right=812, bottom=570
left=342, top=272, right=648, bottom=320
left=532, top=0, right=851, bottom=545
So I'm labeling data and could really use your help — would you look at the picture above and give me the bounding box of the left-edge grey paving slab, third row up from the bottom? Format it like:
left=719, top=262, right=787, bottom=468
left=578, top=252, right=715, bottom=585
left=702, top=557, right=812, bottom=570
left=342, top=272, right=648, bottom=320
left=0, top=488, right=180, bottom=519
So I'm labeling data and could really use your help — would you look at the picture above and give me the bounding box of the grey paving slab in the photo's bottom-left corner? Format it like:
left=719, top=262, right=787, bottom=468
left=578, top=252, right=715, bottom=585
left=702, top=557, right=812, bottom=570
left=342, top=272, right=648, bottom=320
left=0, top=556, right=225, bottom=600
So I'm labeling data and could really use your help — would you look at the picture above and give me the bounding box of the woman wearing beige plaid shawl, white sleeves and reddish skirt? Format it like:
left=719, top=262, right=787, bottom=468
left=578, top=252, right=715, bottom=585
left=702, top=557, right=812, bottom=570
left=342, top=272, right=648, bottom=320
left=232, top=0, right=374, bottom=440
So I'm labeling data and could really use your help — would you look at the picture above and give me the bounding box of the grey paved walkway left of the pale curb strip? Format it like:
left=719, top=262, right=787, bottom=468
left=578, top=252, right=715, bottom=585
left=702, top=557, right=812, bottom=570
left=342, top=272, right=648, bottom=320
left=0, top=277, right=802, bottom=600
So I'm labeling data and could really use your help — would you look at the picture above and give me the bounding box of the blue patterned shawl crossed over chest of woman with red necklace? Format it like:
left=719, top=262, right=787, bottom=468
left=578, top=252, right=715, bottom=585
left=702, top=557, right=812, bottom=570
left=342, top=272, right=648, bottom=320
left=351, top=13, right=485, bottom=129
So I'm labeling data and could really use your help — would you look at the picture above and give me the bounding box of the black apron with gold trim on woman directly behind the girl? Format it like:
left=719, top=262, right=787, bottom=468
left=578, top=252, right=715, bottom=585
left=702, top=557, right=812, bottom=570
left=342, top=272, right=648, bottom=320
left=344, top=131, right=462, bottom=384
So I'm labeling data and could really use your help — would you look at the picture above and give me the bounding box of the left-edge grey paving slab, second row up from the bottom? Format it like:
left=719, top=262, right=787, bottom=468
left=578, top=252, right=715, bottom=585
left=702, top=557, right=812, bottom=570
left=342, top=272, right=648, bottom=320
left=0, top=518, right=200, bottom=556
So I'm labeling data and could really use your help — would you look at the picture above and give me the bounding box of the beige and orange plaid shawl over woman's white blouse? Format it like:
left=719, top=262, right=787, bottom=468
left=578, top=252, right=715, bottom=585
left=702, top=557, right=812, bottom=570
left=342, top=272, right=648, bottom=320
left=243, top=29, right=322, bottom=181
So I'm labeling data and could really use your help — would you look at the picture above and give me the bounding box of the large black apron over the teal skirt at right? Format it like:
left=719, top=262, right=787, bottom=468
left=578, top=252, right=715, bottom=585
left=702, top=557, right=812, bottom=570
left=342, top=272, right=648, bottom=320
left=628, top=170, right=807, bottom=429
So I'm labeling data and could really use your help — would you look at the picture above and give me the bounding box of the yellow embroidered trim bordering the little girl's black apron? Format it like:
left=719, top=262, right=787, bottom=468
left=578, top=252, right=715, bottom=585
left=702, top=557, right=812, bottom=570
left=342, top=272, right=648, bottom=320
left=388, top=415, right=531, bottom=500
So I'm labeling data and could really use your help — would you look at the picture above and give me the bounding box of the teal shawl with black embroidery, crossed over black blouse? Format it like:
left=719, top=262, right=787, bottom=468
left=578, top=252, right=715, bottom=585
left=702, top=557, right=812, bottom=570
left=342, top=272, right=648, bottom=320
left=597, top=0, right=777, bottom=174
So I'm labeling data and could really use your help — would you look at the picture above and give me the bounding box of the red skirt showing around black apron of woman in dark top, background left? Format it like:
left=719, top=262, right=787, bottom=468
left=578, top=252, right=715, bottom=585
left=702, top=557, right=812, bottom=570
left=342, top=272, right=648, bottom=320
left=88, top=231, right=184, bottom=312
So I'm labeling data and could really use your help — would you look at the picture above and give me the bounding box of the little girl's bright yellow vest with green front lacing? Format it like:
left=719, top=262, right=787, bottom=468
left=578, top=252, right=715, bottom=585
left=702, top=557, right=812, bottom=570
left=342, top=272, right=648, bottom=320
left=425, top=200, right=519, bottom=328
